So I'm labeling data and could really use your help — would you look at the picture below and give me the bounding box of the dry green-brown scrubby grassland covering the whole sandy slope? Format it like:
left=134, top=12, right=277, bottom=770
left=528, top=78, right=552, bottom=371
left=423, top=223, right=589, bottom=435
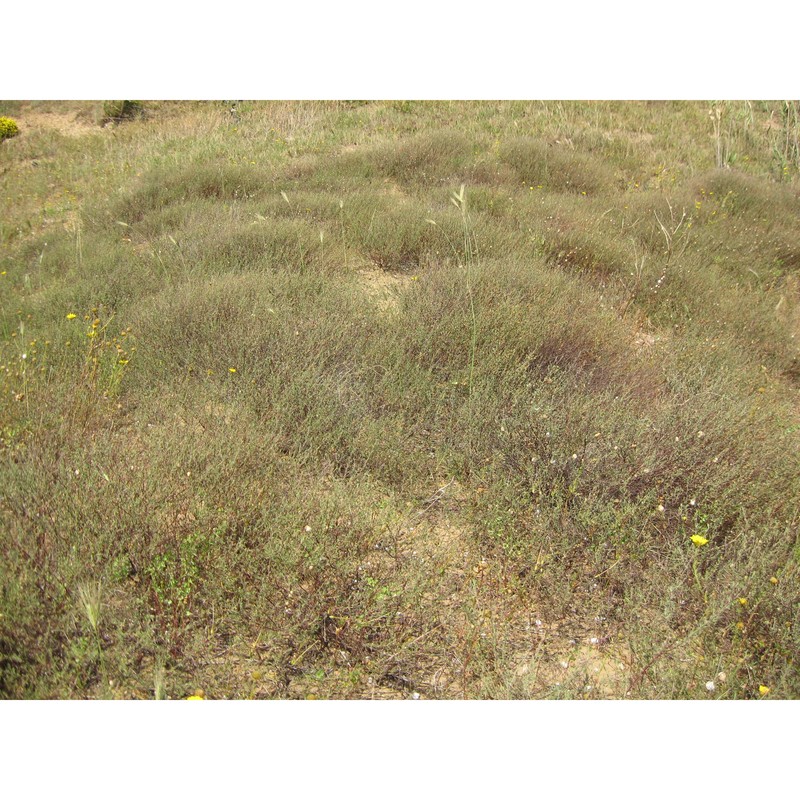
left=0, top=101, right=800, bottom=699
